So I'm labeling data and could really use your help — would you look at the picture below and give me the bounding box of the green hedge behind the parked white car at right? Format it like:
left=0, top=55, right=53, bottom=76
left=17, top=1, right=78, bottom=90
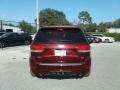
left=86, top=32, right=120, bottom=41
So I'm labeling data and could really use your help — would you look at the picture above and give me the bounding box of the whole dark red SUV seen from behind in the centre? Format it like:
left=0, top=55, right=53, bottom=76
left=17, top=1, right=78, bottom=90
left=30, top=26, right=91, bottom=76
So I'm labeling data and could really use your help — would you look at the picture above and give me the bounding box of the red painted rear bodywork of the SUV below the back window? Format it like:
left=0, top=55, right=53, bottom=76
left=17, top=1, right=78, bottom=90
left=30, top=27, right=91, bottom=75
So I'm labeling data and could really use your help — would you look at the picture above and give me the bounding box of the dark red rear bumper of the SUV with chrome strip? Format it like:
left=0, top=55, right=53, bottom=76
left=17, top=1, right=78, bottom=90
left=30, top=62, right=91, bottom=75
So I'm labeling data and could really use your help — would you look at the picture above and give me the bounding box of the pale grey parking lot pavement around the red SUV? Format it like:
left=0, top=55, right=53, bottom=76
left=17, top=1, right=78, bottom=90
left=0, top=43, right=120, bottom=90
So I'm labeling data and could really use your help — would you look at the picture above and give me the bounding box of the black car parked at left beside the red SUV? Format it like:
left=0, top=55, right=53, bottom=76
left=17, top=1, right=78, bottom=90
left=0, top=32, right=32, bottom=48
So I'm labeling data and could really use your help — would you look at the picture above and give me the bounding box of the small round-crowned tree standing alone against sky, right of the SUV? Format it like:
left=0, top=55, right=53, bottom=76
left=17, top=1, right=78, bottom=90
left=78, top=11, right=92, bottom=24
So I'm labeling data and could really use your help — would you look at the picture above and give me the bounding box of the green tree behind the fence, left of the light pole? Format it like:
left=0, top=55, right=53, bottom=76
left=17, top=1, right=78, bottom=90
left=18, top=20, right=36, bottom=33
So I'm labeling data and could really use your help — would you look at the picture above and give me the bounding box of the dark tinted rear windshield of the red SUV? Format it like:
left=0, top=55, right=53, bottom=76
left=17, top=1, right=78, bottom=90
left=35, top=28, right=86, bottom=43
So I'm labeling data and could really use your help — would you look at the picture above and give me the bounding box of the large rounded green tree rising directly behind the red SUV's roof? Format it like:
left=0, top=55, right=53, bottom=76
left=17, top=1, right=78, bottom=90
left=39, top=8, right=70, bottom=26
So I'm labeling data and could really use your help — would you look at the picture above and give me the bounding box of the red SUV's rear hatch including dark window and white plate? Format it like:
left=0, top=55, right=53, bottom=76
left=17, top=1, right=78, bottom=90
left=31, top=28, right=90, bottom=63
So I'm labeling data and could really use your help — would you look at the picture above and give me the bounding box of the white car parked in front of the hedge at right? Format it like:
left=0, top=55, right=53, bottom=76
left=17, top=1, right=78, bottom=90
left=93, top=34, right=115, bottom=43
